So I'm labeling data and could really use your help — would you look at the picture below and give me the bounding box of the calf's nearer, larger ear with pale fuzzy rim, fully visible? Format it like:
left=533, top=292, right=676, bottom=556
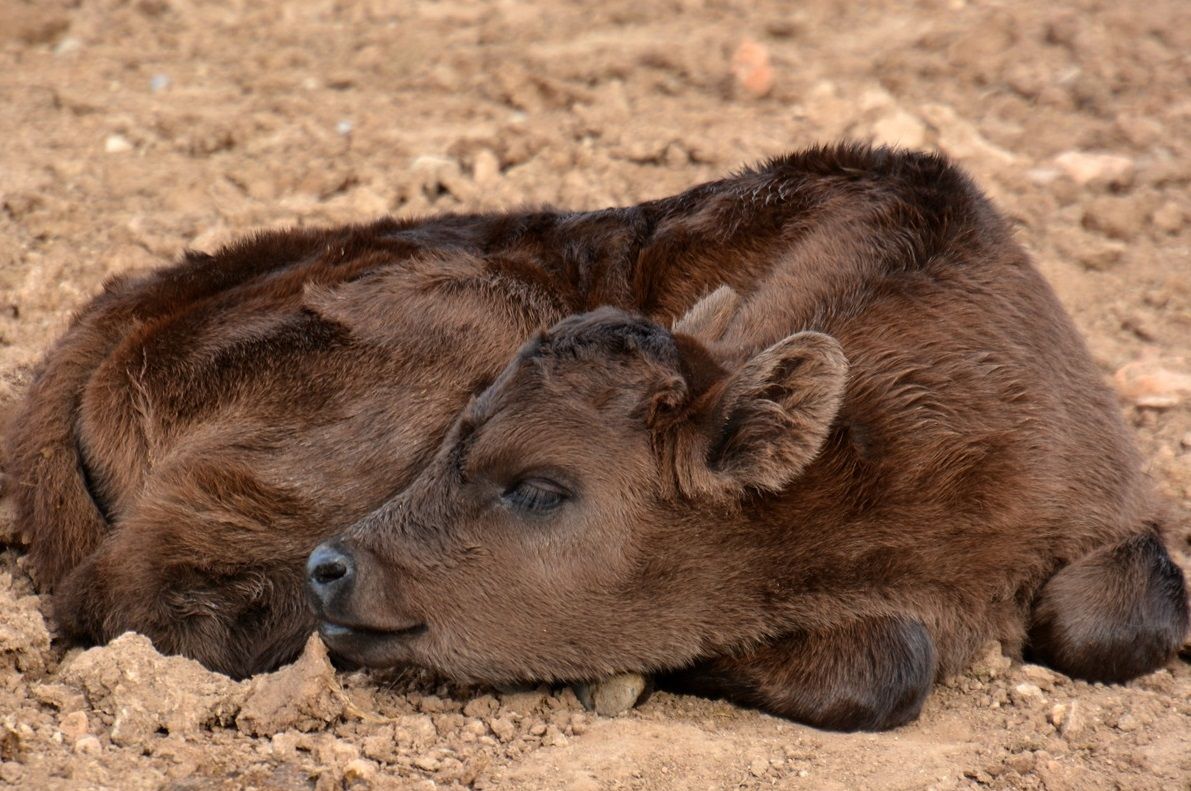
left=706, top=332, right=848, bottom=491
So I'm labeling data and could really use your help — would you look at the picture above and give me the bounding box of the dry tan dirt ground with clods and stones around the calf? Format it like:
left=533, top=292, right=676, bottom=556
left=0, top=0, right=1191, bottom=791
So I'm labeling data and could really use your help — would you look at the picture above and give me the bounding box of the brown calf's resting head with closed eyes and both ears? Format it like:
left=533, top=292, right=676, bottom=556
left=307, top=289, right=847, bottom=681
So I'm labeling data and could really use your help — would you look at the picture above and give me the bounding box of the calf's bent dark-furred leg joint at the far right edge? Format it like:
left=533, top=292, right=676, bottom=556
left=1027, top=532, right=1187, bottom=683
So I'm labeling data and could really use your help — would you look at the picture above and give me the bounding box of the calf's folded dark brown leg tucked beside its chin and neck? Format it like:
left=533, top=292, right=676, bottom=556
left=659, top=617, right=935, bottom=730
